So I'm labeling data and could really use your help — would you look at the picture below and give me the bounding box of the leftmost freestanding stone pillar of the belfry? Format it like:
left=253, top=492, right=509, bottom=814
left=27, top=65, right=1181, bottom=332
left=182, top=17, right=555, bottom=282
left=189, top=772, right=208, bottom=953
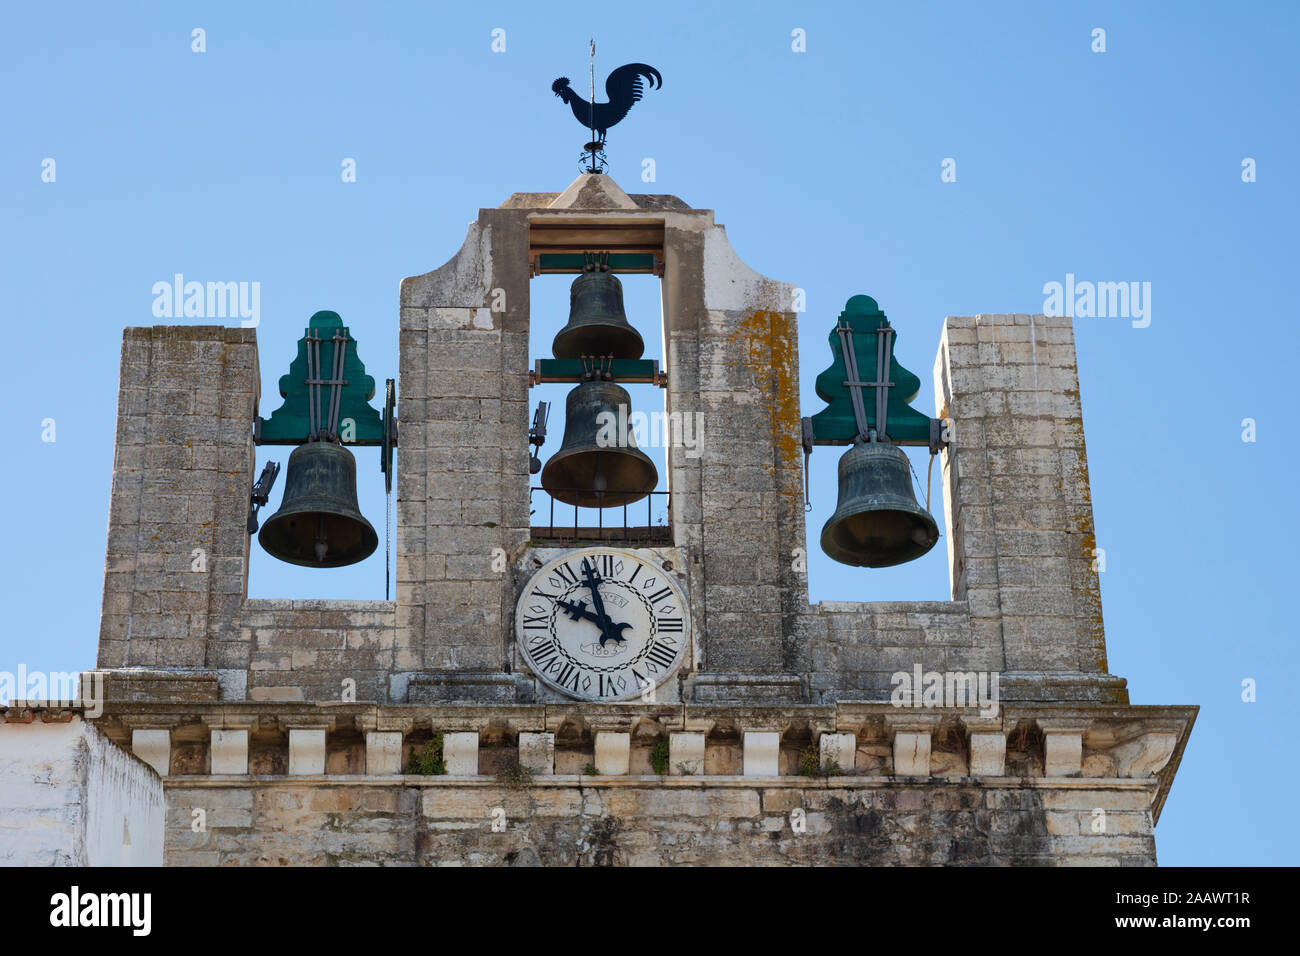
left=99, top=325, right=260, bottom=676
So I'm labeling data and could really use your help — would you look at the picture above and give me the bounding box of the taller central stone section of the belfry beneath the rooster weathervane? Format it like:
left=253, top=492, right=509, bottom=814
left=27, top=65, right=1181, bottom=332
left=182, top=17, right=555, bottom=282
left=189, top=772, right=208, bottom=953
left=398, top=173, right=807, bottom=701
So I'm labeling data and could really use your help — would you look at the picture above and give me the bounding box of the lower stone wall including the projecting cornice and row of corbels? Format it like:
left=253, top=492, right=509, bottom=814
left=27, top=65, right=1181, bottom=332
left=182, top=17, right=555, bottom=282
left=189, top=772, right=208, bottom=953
left=76, top=701, right=1195, bottom=865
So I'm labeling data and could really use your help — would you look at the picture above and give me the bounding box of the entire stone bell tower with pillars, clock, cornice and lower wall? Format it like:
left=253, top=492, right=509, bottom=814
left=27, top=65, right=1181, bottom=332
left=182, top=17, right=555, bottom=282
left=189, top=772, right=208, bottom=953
left=81, top=174, right=1196, bottom=865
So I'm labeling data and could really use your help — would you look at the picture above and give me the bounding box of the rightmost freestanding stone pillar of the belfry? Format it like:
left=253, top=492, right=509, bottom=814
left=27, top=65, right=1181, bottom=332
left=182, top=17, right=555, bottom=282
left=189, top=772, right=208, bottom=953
left=935, top=315, right=1127, bottom=704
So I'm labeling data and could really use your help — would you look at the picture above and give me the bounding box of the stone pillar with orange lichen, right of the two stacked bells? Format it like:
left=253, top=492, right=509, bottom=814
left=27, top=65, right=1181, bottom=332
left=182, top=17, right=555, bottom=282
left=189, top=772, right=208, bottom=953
left=663, top=213, right=807, bottom=702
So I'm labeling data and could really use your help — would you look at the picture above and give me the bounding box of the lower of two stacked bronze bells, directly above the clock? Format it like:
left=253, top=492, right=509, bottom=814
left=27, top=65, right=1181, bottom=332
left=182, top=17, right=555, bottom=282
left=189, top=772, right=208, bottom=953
left=542, top=381, right=659, bottom=507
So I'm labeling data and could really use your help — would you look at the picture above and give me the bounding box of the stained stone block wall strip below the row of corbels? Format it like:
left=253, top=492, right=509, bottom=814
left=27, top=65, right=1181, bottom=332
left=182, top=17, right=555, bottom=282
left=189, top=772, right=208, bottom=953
left=159, top=777, right=1156, bottom=866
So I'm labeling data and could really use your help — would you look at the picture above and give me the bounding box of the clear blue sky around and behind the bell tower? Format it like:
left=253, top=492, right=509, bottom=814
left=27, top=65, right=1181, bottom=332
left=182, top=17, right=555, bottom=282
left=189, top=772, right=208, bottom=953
left=0, top=1, right=1300, bottom=864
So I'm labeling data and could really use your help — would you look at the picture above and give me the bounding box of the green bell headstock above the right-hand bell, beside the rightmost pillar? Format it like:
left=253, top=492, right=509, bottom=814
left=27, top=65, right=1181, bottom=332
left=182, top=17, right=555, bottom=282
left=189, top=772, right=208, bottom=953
left=802, top=295, right=946, bottom=454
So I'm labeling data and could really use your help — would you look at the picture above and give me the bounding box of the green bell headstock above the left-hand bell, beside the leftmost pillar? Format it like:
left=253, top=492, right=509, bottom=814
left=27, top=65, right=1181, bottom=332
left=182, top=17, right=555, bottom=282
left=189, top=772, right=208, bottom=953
left=254, top=311, right=397, bottom=447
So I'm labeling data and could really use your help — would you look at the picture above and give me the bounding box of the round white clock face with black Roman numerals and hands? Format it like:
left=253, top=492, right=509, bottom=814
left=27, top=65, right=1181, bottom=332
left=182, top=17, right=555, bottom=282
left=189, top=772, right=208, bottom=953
left=515, top=548, right=690, bottom=701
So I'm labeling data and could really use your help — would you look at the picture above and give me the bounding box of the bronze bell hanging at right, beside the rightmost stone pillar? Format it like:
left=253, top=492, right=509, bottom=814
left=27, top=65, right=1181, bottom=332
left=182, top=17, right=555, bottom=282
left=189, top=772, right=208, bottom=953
left=822, top=442, right=939, bottom=567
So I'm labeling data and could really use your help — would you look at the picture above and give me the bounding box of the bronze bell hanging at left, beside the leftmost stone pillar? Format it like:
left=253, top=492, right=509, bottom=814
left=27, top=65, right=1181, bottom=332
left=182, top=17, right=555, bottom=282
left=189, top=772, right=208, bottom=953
left=257, top=441, right=380, bottom=567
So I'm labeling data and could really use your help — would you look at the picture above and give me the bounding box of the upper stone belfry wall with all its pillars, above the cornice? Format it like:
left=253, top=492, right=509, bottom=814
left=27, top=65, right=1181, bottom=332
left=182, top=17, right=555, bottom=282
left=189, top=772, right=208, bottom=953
left=99, top=187, right=1127, bottom=704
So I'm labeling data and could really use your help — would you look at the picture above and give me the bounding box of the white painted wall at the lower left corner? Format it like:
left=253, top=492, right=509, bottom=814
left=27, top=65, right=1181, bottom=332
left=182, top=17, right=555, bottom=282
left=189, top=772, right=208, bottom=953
left=0, top=715, right=164, bottom=866
